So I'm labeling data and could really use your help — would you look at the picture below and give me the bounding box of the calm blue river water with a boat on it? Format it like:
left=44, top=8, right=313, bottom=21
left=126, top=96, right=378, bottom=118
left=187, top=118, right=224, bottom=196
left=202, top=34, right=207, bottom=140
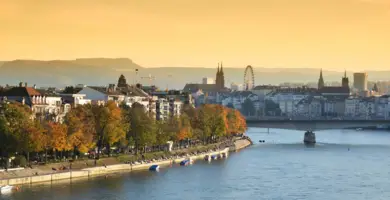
left=0, top=128, right=390, bottom=200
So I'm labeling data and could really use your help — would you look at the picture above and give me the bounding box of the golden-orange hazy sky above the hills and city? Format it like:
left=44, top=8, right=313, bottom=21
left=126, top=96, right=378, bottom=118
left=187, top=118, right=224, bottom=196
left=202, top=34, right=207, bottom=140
left=0, top=0, right=390, bottom=71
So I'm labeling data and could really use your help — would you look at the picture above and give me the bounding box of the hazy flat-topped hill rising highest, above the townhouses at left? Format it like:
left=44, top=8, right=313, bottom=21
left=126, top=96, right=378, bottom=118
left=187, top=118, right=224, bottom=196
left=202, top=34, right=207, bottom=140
left=0, top=58, right=142, bottom=86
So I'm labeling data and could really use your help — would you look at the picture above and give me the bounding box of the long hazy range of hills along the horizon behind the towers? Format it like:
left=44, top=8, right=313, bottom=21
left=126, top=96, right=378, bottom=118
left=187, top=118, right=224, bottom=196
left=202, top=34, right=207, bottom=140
left=0, top=58, right=390, bottom=89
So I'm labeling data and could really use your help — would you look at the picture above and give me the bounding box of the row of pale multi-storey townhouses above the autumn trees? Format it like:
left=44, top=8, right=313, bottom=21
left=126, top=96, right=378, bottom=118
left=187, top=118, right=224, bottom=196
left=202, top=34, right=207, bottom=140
left=0, top=75, right=194, bottom=121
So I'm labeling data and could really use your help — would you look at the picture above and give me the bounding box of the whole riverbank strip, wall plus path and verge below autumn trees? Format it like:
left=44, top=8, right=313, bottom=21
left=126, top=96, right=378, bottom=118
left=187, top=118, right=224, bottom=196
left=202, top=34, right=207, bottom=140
left=0, top=137, right=251, bottom=186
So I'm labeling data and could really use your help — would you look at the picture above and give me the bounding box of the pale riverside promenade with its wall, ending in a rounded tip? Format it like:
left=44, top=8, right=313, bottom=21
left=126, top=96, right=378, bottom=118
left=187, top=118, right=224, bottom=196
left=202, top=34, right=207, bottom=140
left=0, top=138, right=251, bottom=186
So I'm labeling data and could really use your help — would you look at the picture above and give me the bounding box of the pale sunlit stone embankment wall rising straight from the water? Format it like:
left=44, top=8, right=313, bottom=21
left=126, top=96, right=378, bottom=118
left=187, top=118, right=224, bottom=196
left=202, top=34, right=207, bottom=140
left=0, top=148, right=229, bottom=186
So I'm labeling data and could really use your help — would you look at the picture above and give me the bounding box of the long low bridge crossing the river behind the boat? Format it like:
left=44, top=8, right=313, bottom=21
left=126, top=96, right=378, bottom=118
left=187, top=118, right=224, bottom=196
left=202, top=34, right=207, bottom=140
left=247, top=119, right=390, bottom=131
